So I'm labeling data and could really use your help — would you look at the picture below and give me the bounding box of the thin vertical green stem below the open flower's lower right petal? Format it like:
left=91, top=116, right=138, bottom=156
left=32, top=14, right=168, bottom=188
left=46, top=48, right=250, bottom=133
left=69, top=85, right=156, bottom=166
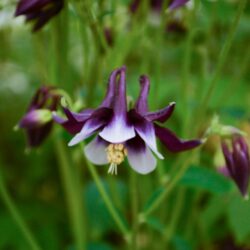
left=130, top=171, right=139, bottom=250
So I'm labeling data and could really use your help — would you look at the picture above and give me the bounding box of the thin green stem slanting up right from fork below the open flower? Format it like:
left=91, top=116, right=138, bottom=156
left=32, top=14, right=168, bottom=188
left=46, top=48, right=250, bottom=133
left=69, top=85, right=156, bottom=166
left=139, top=153, right=195, bottom=222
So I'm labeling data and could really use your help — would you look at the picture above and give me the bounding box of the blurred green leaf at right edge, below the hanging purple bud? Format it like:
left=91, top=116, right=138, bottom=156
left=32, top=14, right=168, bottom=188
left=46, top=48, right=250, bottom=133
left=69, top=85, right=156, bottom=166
left=228, top=196, right=250, bottom=243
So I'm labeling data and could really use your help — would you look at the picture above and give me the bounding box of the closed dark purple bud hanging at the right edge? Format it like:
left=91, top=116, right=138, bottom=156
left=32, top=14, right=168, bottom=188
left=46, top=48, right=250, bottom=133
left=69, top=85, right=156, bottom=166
left=221, top=136, right=250, bottom=197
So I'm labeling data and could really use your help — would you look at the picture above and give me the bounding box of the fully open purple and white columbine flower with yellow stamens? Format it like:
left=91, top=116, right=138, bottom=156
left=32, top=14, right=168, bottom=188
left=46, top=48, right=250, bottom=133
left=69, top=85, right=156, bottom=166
left=55, top=67, right=201, bottom=174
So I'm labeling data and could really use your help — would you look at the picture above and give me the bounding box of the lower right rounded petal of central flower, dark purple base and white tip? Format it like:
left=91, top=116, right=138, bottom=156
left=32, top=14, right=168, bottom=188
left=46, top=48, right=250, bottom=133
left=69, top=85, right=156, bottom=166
left=125, top=136, right=156, bottom=174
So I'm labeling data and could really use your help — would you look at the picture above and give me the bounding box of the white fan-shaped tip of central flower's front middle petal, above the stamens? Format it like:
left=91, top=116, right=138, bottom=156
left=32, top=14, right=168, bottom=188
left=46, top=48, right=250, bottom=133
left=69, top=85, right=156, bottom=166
left=99, top=117, right=135, bottom=143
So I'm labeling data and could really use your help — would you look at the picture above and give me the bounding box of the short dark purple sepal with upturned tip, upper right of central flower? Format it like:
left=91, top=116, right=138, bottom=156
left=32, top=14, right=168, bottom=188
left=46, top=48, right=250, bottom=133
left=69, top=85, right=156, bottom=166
left=145, top=102, right=175, bottom=123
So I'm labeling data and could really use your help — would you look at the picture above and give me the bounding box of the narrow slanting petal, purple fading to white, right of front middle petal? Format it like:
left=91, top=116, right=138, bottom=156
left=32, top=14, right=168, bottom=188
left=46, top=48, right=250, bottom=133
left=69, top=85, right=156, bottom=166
left=129, top=110, right=163, bottom=159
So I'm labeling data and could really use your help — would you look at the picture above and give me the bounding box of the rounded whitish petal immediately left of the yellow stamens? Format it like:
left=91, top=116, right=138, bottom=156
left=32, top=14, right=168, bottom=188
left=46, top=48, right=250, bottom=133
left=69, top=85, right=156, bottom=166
left=84, top=137, right=108, bottom=165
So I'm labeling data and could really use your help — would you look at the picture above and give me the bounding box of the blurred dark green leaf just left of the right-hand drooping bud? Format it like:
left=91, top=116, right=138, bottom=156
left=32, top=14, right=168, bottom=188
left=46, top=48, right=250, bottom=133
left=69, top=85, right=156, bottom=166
left=179, top=167, right=232, bottom=194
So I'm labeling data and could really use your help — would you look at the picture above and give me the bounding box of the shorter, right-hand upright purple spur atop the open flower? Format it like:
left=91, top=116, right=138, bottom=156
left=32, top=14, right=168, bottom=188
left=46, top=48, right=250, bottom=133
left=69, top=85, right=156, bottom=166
left=135, top=75, right=150, bottom=115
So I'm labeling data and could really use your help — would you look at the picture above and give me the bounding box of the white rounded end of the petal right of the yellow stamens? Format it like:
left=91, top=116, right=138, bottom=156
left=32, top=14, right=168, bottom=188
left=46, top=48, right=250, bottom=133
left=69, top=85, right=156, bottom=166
left=127, top=147, right=156, bottom=174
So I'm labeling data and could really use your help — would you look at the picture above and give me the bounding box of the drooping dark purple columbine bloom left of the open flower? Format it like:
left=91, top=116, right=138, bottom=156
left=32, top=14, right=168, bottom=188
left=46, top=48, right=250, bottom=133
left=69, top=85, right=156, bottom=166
left=17, top=86, right=60, bottom=147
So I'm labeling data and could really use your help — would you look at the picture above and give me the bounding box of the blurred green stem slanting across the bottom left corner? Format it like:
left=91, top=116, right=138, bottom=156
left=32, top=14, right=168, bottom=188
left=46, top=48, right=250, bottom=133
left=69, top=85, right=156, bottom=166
left=0, top=170, right=41, bottom=250
